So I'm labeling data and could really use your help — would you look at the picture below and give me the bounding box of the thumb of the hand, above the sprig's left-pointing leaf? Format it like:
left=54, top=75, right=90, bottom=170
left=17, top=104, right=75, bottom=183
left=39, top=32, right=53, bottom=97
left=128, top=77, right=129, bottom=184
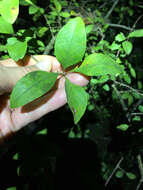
left=0, top=59, right=52, bottom=94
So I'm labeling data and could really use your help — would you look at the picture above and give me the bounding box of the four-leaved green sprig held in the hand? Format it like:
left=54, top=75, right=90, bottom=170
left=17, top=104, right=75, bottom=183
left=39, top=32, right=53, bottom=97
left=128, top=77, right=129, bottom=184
left=10, top=17, right=123, bottom=123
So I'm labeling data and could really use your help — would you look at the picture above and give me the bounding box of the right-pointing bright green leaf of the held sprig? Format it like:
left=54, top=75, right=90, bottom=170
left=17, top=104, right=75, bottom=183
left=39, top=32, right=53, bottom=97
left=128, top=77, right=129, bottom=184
left=72, top=53, right=123, bottom=76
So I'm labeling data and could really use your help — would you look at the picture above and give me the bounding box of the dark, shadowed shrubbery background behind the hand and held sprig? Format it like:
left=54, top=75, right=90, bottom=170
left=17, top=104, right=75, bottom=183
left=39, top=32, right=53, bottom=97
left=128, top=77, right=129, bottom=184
left=0, top=0, right=143, bottom=190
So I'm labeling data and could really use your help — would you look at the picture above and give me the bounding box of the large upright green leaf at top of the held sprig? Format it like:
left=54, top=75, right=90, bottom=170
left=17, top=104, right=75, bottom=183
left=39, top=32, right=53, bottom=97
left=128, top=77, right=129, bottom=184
left=54, top=17, right=86, bottom=68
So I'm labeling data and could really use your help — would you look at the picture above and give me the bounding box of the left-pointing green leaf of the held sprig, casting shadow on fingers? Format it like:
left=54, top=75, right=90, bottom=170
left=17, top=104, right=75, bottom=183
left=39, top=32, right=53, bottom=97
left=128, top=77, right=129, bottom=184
left=10, top=71, right=58, bottom=108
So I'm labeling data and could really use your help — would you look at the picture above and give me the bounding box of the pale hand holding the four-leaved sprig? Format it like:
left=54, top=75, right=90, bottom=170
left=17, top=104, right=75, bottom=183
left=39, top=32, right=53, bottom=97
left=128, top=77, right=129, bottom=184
left=0, top=55, right=88, bottom=141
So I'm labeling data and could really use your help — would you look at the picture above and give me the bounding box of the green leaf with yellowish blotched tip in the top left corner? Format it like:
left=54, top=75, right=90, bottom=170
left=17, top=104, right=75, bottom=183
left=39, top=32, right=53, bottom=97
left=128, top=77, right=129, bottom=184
left=0, top=0, right=19, bottom=24
